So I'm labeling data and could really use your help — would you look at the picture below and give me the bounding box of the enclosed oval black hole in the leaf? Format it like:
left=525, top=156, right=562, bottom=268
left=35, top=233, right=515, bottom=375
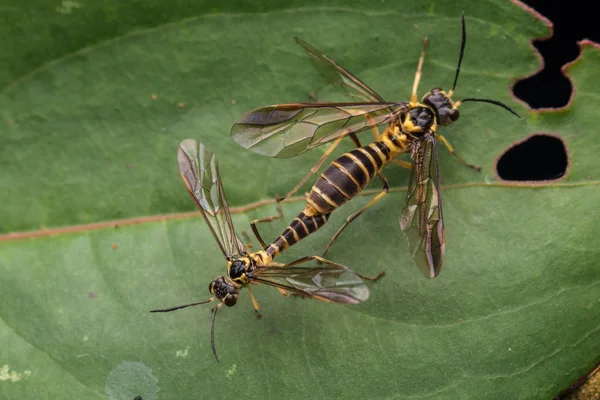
left=496, top=134, right=569, bottom=181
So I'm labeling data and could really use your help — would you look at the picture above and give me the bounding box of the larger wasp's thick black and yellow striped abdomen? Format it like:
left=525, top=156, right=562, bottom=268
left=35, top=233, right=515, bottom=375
left=305, top=142, right=392, bottom=216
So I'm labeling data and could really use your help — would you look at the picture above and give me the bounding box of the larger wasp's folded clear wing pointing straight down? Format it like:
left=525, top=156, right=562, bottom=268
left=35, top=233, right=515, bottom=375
left=400, top=133, right=446, bottom=278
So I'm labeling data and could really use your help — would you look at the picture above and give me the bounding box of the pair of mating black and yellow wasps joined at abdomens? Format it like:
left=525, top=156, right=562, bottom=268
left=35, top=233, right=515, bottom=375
left=152, top=13, right=518, bottom=361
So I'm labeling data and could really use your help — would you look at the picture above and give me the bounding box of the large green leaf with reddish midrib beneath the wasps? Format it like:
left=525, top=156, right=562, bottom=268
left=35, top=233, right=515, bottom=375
left=0, top=1, right=600, bottom=400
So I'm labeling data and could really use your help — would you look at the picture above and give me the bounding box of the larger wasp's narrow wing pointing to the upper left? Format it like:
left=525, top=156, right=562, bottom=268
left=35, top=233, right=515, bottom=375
left=294, top=37, right=385, bottom=103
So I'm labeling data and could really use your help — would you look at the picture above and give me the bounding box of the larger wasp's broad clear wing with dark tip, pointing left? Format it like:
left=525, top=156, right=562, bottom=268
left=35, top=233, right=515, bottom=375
left=231, top=103, right=407, bottom=158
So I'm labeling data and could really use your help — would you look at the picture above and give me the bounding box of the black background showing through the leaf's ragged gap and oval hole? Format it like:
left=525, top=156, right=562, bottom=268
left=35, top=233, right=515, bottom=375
left=497, top=0, right=600, bottom=181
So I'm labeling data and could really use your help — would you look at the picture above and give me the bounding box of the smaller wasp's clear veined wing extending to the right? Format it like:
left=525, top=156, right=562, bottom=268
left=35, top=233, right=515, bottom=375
left=250, top=266, right=369, bottom=304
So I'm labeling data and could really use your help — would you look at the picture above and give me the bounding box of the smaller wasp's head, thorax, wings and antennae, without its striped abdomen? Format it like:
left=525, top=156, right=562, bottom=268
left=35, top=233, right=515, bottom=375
left=151, top=139, right=382, bottom=362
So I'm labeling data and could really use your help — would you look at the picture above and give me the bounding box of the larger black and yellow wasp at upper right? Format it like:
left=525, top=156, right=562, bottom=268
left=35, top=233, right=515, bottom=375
left=231, top=13, right=518, bottom=278
